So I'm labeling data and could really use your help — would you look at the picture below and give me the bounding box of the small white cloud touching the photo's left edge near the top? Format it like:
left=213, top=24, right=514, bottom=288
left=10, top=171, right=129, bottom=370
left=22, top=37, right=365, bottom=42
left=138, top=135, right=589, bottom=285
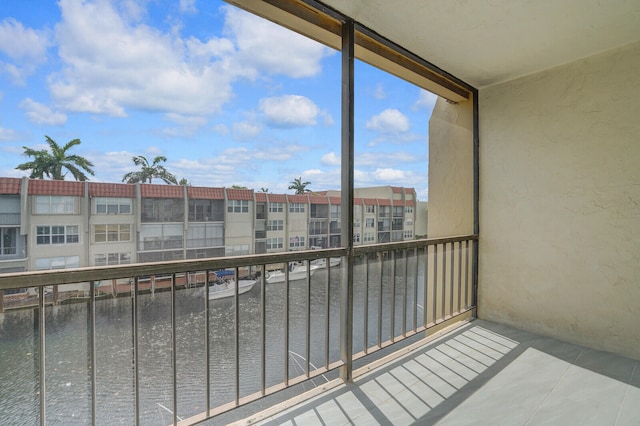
left=0, top=18, right=51, bottom=84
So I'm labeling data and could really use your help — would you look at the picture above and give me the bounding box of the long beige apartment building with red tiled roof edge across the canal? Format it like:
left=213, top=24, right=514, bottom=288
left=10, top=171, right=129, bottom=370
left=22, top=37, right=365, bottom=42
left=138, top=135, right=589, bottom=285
left=0, top=178, right=426, bottom=272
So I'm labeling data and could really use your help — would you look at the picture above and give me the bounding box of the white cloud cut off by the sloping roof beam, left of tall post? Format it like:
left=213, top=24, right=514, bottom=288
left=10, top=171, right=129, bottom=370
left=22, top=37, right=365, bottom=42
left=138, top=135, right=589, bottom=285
left=224, top=7, right=334, bottom=78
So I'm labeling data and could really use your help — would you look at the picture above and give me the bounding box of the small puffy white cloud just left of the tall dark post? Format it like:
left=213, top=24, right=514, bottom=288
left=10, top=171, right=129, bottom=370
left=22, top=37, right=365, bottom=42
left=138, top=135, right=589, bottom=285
left=259, top=95, right=318, bottom=127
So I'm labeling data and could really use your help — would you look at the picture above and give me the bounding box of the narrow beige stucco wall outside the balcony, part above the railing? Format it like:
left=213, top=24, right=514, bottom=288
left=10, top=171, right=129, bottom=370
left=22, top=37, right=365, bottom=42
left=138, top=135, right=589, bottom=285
left=427, top=98, right=473, bottom=238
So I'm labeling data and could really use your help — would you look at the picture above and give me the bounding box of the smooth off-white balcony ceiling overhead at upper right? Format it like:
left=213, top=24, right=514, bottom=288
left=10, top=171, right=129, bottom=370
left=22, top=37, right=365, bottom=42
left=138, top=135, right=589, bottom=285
left=321, top=0, right=640, bottom=88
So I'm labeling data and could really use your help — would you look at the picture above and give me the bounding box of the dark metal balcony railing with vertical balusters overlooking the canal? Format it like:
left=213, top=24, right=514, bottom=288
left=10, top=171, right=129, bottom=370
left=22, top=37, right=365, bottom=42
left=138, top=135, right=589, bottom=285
left=0, top=235, right=477, bottom=424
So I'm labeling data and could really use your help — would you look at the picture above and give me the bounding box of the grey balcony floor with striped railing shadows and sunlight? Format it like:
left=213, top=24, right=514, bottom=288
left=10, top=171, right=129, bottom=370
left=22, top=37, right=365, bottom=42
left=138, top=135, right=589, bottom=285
left=238, top=320, right=640, bottom=426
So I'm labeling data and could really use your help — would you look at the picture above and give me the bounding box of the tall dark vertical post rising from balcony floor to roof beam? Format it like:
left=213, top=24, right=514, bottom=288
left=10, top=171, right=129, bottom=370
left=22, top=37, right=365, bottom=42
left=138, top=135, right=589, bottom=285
left=340, top=19, right=355, bottom=382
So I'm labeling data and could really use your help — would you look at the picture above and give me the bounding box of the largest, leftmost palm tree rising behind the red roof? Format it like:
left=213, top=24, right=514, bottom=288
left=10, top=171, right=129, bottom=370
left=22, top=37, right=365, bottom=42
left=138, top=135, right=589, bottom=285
left=16, top=135, right=95, bottom=181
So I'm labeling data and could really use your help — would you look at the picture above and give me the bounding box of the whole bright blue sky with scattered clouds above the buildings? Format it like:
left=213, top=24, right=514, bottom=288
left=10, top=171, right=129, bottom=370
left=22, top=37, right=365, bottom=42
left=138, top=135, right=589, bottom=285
left=0, top=0, right=436, bottom=200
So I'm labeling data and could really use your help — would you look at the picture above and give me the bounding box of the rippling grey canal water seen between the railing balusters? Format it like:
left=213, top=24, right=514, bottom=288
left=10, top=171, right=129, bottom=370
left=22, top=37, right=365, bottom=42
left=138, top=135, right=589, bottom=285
left=0, top=262, right=422, bottom=425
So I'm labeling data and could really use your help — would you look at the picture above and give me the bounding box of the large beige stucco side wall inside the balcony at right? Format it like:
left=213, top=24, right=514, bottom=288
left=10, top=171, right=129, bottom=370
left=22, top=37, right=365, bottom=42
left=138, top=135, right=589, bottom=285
left=480, top=40, right=640, bottom=359
